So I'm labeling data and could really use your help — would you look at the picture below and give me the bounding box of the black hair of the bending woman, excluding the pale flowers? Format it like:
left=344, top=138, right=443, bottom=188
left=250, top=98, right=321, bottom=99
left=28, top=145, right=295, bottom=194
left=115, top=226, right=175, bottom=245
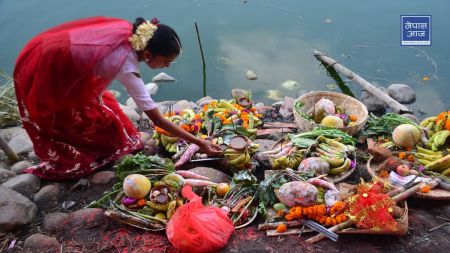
left=133, top=17, right=181, bottom=57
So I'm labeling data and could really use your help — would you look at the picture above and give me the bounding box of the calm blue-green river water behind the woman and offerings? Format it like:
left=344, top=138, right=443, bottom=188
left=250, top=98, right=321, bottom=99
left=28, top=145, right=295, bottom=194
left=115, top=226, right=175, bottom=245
left=0, top=0, right=450, bottom=114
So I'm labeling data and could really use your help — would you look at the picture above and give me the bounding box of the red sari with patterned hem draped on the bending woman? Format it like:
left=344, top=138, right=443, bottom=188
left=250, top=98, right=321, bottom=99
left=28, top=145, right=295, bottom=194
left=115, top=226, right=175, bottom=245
left=14, top=17, right=143, bottom=180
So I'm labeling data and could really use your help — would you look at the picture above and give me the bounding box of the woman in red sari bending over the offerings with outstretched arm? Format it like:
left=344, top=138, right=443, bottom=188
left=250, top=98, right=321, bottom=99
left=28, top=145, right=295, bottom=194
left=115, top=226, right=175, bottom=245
left=14, top=17, right=220, bottom=180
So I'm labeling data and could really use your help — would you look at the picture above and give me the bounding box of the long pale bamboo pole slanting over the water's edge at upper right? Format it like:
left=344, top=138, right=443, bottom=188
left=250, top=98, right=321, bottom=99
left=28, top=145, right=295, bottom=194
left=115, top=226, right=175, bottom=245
left=314, top=50, right=411, bottom=113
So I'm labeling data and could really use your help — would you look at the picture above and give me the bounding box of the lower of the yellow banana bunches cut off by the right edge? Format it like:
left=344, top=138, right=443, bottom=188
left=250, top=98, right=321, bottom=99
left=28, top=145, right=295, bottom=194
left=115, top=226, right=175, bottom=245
left=415, top=146, right=450, bottom=176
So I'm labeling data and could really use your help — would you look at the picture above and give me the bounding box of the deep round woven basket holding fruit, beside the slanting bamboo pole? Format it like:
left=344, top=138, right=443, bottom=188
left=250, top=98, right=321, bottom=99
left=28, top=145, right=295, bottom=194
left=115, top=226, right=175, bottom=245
left=293, top=91, right=369, bottom=135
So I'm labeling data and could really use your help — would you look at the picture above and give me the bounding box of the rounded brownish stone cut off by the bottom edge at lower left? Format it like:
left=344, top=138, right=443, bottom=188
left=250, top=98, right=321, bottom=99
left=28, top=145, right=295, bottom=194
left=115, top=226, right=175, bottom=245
left=23, top=234, right=61, bottom=253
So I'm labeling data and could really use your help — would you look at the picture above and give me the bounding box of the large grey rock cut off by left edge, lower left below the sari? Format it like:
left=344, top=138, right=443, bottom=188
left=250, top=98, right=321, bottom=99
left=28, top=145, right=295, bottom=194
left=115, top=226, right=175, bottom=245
left=0, top=186, right=37, bottom=233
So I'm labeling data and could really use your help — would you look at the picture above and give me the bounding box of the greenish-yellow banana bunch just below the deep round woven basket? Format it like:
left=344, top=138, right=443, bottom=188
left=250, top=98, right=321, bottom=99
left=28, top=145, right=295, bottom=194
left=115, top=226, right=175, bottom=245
left=315, top=136, right=355, bottom=175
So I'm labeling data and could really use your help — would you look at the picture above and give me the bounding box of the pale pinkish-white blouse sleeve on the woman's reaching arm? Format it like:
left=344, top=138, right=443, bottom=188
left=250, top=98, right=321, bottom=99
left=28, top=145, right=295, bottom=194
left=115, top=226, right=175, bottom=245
left=115, top=51, right=158, bottom=111
